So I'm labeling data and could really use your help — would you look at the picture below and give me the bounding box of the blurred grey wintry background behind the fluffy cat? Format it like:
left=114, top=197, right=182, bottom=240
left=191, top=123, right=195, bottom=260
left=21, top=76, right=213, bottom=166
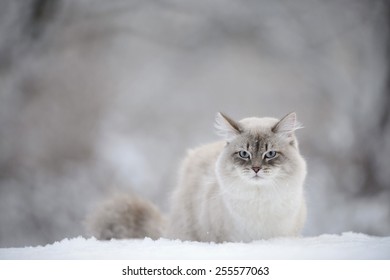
left=0, top=0, right=390, bottom=247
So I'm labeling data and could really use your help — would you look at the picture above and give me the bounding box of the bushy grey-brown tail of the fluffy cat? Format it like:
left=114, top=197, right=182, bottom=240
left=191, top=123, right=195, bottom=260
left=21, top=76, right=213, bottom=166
left=86, top=194, right=165, bottom=240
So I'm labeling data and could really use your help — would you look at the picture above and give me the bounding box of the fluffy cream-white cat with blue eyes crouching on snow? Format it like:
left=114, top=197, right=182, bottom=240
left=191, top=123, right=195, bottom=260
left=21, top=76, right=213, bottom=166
left=89, top=112, right=307, bottom=243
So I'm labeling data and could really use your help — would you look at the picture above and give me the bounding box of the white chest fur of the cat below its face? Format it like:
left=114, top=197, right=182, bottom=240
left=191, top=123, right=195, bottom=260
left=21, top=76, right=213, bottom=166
left=222, top=180, right=305, bottom=242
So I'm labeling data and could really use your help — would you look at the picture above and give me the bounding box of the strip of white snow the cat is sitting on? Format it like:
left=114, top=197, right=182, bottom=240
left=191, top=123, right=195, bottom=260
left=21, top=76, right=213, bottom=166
left=0, top=232, right=390, bottom=260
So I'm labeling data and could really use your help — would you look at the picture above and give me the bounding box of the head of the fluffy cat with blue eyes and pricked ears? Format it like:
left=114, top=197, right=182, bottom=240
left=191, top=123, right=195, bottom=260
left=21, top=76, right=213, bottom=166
left=215, top=113, right=306, bottom=185
